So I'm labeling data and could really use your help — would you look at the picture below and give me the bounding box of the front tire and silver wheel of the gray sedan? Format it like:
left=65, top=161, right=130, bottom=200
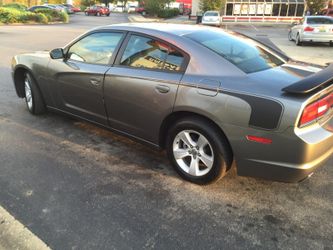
left=24, top=72, right=46, bottom=115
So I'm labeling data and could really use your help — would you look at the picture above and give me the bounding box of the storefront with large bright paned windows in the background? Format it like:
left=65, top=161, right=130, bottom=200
left=192, top=0, right=306, bottom=22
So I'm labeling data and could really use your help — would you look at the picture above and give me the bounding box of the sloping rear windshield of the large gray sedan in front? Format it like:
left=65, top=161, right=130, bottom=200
left=185, top=31, right=284, bottom=73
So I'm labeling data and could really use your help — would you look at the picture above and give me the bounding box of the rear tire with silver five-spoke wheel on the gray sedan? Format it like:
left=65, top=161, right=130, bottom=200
left=166, top=117, right=232, bottom=185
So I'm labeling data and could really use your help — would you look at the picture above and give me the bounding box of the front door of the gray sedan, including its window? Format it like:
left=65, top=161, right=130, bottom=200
left=49, top=31, right=123, bottom=125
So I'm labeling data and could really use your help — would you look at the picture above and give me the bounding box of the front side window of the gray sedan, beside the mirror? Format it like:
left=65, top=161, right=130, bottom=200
left=68, top=33, right=123, bottom=64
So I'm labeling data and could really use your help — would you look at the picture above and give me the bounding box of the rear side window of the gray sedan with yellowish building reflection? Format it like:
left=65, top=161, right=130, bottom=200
left=120, top=35, right=184, bottom=71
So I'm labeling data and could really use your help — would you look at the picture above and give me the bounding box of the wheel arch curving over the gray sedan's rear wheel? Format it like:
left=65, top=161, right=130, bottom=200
left=159, top=111, right=233, bottom=164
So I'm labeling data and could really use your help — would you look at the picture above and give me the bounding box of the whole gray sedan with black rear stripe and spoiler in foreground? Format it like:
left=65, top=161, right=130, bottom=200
left=12, top=23, right=333, bottom=184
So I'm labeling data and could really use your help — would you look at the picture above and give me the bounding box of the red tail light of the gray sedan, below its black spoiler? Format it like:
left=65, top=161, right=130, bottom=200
left=299, top=93, right=333, bottom=127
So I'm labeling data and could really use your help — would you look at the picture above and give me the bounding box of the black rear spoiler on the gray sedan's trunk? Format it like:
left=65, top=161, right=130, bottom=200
left=282, top=63, right=333, bottom=94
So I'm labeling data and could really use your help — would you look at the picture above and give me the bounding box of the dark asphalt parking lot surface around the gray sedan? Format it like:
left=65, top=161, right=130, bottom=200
left=0, top=13, right=333, bottom=250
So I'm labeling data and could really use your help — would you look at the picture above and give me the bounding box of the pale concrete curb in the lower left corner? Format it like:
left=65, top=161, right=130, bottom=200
left=0, top=206, right=50, bottom=250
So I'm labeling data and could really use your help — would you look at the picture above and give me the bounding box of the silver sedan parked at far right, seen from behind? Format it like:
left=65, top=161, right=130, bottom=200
left=288, top=16, right=333, bottom=46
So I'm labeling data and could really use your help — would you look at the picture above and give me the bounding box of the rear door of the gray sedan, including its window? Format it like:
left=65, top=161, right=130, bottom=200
left=104, top=33, right=188, bottom=143
